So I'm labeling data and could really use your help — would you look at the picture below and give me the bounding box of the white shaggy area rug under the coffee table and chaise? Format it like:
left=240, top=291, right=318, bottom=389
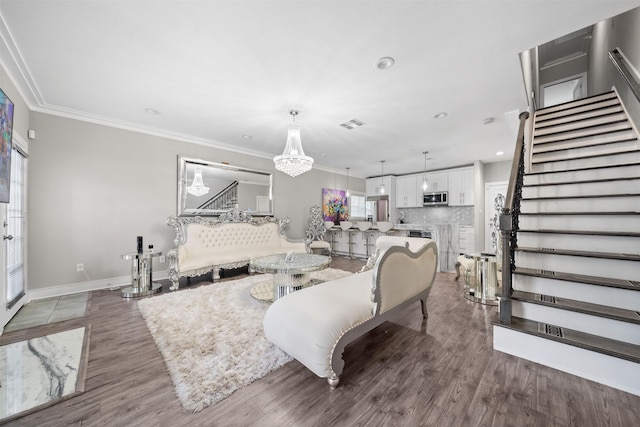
left=138, top=268, right=353, bottom=412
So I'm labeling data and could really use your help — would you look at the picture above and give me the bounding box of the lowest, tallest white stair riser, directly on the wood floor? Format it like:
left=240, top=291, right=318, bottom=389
left=493, top=325, right=640, bottom=396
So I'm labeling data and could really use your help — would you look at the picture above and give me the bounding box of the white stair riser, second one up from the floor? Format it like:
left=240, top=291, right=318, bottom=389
left=511, top=300, right=640, bottom=345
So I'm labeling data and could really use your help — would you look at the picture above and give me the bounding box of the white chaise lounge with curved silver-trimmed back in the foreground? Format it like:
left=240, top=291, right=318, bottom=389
left=263, top=236, right=438, bottom=389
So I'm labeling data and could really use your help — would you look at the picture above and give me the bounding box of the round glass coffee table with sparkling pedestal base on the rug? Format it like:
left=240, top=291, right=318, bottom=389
left=249, top=253, right=331, bottom=302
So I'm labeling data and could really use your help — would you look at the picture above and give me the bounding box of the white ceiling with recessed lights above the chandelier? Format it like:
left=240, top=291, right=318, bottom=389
left=0, top=0, right=640, bottom=177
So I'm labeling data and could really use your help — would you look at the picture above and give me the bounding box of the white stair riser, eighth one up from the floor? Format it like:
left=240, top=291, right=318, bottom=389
left=522, top=178, right=640, bottom=198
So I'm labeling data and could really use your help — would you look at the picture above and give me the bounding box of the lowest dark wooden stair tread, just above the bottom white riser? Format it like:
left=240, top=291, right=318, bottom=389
left=492, top=316, right=640, bottom=363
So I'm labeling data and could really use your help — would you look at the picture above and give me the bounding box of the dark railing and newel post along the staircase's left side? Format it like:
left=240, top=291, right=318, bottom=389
left=499, top=111, right=529, bottom=324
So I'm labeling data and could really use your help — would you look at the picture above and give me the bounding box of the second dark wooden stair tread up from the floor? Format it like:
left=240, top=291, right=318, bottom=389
left=511, top=291, right=640, bottom=325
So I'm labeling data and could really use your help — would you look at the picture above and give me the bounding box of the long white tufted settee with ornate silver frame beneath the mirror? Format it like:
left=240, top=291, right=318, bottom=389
left=167, top=211, right=307, bottom=290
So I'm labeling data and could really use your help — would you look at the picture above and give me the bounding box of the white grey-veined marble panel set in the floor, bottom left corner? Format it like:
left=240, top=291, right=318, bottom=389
left=0, top=328, right=85, bottom=423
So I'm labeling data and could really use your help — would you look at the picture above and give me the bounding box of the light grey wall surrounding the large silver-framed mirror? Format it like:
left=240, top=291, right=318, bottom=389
left=28, top=113, right=364, bottom=290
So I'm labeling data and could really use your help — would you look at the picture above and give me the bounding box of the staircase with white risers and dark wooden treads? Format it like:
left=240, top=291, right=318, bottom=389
left=494, top=92, right=640, bottom=395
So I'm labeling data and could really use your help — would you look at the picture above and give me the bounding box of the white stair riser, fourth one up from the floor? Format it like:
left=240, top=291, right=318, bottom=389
left=516, top=251, right=640, bottom=280
